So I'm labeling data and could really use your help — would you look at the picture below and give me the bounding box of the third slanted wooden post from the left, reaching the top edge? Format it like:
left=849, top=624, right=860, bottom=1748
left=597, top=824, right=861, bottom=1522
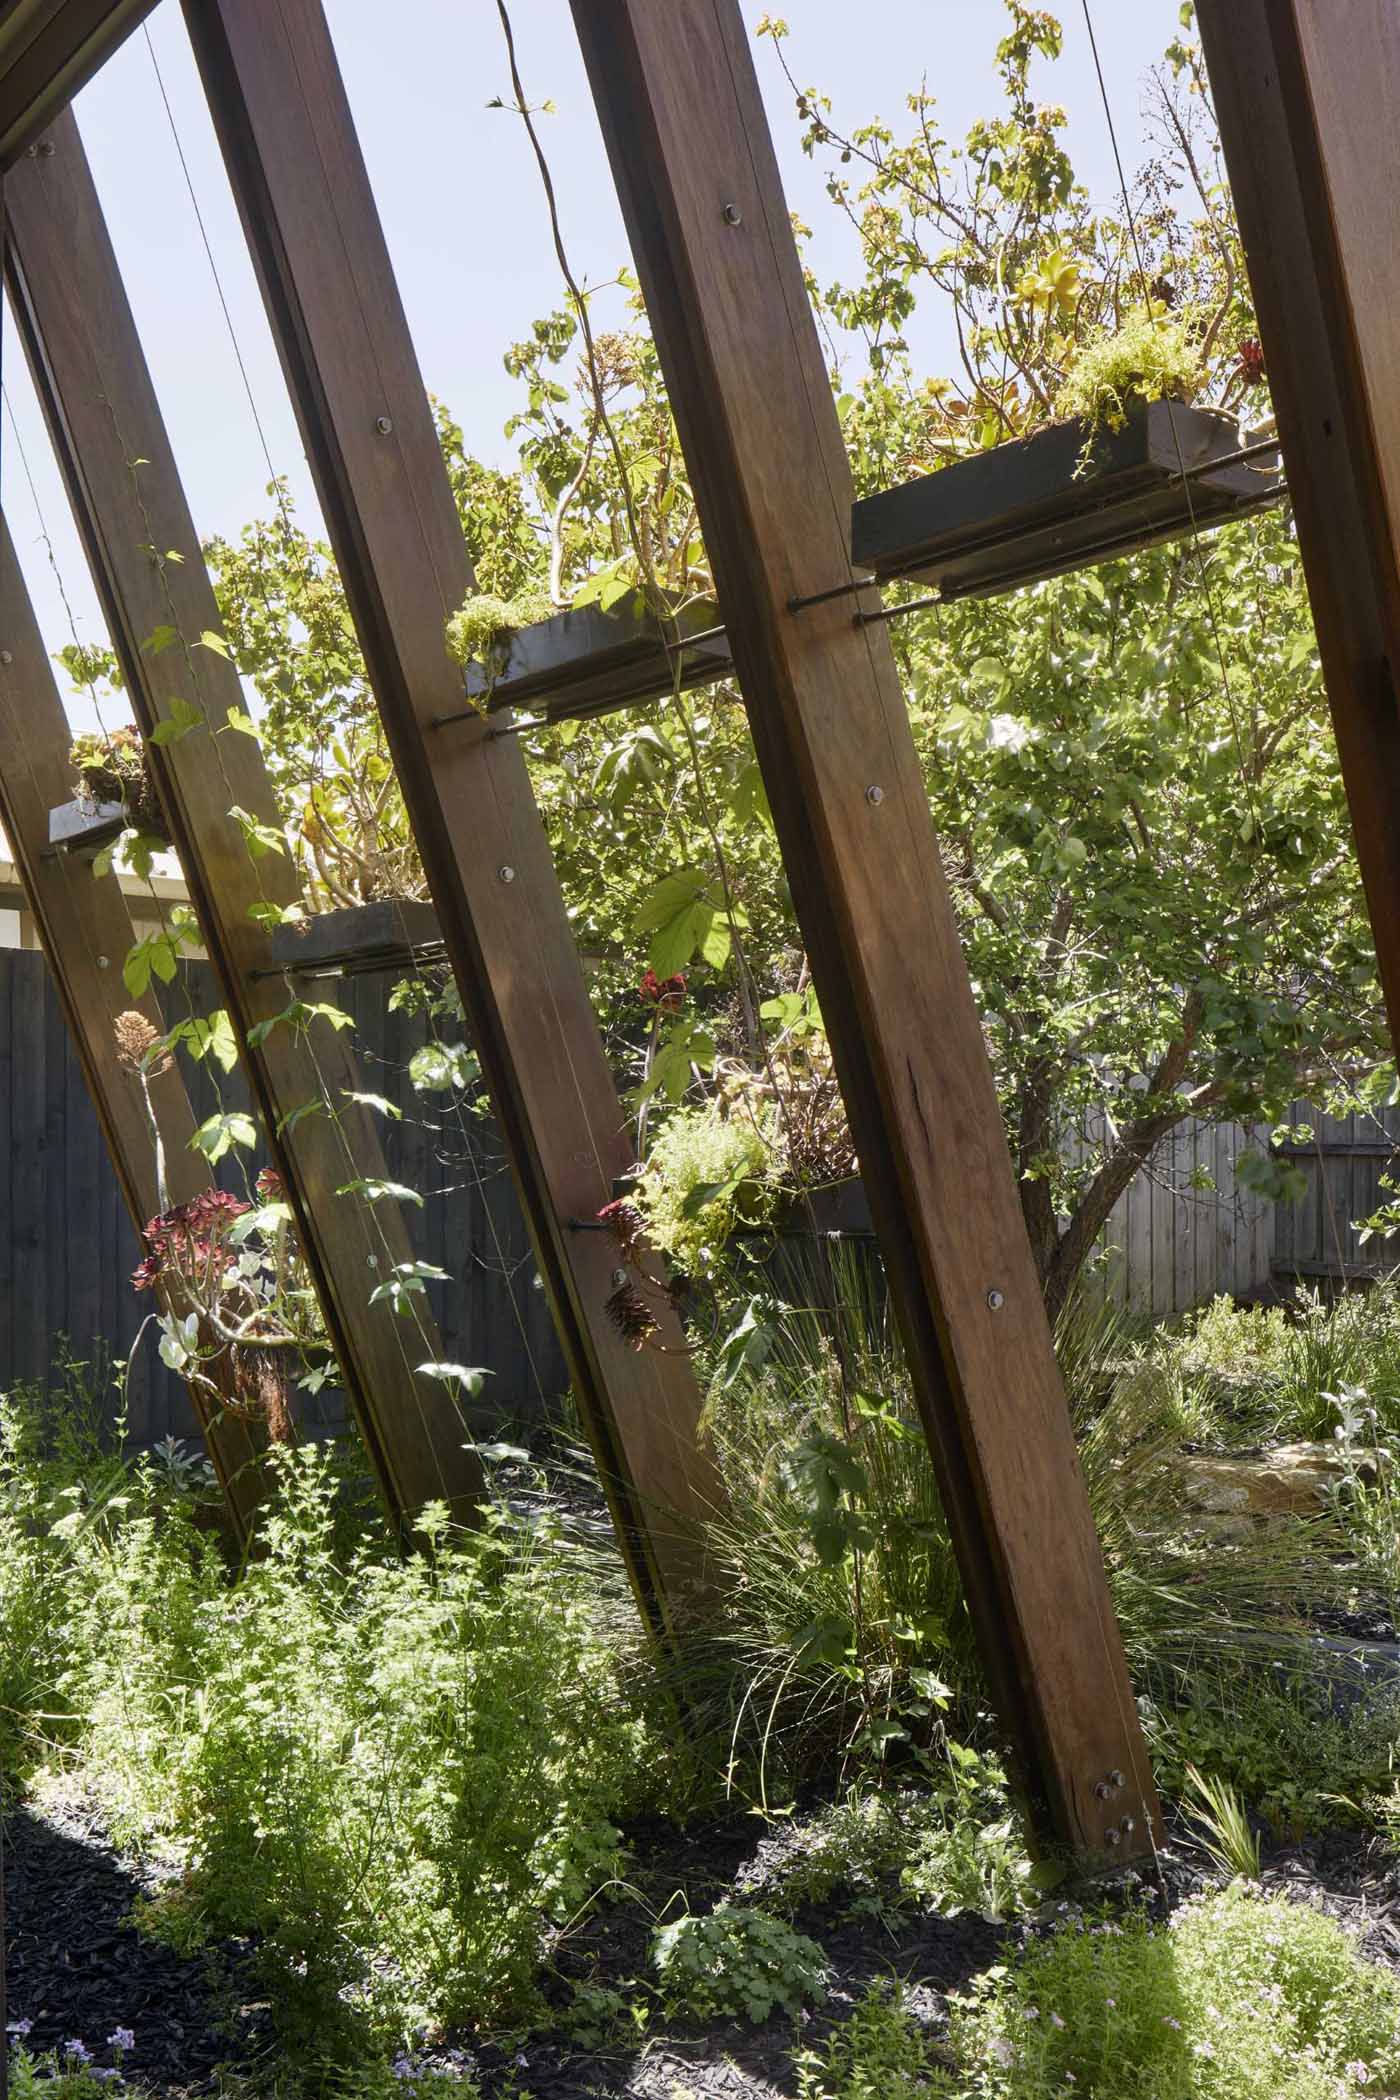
left=185, top=0, right=718, bottom=1611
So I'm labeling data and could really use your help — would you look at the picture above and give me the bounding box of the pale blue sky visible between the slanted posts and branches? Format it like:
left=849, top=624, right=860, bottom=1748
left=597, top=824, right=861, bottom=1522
left=0, top=0, right=1178, bottom=720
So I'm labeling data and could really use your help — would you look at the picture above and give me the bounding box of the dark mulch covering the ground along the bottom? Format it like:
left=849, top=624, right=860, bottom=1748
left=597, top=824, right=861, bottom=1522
left=6, top=1802, right=1400, bottom=2100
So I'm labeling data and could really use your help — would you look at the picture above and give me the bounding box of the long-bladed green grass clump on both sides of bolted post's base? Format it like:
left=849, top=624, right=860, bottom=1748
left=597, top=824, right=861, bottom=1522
left=688, top=1264, right=1345, bottom=1789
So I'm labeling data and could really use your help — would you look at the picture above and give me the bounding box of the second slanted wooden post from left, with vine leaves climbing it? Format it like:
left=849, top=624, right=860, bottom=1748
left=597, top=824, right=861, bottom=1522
left=4, top=113, right=481, bottom=1520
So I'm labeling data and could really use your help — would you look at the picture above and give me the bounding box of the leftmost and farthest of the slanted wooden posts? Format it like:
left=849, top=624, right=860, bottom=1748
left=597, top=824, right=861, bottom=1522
left=0, top=519, right=262, bottom=1539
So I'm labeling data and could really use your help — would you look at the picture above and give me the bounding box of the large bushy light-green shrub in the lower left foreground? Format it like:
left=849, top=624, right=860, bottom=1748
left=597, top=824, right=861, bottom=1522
left=13, top=1447, right=657, bottom=2048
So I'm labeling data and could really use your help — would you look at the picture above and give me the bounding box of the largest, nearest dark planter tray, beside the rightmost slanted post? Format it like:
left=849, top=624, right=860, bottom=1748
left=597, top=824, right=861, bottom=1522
left=850, top=401, right=1285, bottom=599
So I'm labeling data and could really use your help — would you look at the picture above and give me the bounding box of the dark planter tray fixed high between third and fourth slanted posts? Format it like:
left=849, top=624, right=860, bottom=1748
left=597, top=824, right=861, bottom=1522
left=443, top=590, right=730, bottom=722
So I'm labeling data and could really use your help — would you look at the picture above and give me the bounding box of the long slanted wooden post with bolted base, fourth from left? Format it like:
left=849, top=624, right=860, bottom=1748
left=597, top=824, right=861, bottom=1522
left=573, top=0, right=1157, bottom=1859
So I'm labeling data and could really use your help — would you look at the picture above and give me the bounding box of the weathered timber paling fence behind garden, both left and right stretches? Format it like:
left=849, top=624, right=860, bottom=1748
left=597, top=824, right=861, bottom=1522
left=0, top=949, right=1400, bottom=1443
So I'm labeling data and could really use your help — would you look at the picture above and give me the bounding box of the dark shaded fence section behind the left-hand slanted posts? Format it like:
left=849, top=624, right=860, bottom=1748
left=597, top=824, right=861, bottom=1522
left=0, top=949, right=567, bottom=1445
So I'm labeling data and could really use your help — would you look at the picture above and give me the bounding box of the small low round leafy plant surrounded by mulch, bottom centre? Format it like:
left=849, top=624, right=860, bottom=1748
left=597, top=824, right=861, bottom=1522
left=653, top=1907, right=827, bottom=2022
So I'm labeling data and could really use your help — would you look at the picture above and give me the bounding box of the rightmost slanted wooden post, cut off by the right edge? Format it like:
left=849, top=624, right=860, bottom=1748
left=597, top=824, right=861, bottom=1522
left=1199, top=0, right=1400, bottom=1044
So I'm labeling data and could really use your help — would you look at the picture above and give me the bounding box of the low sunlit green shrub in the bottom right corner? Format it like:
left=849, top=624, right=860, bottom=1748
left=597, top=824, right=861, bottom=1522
left=951, top=1884, right=1400, bottom=2100
